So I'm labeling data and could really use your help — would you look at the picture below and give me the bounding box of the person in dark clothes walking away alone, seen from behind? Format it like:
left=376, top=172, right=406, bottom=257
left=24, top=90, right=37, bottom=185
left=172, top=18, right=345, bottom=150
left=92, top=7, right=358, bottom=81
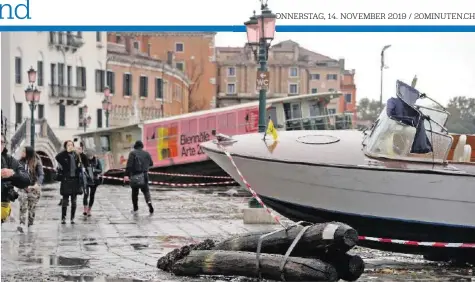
left=124, top=140, right=154, bottom=214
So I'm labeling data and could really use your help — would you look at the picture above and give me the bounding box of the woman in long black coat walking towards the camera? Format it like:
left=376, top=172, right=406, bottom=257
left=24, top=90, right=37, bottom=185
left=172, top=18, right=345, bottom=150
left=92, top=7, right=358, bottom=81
left=56, top=140, right=88, bottom=224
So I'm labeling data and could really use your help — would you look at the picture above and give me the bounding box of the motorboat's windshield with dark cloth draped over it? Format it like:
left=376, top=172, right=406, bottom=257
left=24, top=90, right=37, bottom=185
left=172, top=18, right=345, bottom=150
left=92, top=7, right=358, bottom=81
left=364, top=81, right=452, bottom=162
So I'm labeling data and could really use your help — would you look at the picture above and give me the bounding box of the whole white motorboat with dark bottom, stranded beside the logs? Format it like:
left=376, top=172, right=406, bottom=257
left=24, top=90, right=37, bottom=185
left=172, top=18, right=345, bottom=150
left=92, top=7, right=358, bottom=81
left=201, top=81, right=475, bottom=258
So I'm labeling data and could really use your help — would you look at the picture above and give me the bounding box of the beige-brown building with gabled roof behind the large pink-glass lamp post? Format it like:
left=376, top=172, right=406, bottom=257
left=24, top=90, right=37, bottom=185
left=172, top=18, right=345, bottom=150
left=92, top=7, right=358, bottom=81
left=216, top=40, right=356, bottom=112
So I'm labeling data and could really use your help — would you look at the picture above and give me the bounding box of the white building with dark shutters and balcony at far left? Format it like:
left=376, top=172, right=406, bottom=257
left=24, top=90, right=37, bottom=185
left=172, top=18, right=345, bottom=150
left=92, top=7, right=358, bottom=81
left=1, top=32, right=107, bottom=141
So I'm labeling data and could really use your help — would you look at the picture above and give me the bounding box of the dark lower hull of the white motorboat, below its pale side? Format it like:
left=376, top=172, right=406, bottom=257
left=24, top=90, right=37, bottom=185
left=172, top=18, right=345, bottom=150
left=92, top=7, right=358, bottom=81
left=259, top=195, right=475, bottom=261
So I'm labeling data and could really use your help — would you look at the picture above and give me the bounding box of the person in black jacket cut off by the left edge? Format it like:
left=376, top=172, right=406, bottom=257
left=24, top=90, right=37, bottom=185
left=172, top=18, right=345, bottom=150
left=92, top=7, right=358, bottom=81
left=1, top=130, right=30, bottom=223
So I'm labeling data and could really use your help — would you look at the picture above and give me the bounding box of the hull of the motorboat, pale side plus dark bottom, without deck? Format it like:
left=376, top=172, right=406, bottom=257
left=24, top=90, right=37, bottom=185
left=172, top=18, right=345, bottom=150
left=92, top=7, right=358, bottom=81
left=202, top=133, right=475, bottom=256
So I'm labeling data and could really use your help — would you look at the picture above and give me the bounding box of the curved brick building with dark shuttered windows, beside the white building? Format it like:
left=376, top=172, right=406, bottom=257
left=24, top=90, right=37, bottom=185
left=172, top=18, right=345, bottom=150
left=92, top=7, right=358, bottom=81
left=106, top=38, right=190, bottom=126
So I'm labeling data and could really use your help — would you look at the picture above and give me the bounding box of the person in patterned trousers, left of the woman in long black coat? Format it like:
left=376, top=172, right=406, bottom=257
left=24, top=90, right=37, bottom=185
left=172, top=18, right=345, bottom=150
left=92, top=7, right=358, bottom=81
left=17, top=146, right=45, bottom=233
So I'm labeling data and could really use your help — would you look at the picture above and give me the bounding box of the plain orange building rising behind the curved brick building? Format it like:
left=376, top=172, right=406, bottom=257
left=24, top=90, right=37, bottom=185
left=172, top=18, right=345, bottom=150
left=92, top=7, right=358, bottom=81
left=108, top=32, right=216, bottom=111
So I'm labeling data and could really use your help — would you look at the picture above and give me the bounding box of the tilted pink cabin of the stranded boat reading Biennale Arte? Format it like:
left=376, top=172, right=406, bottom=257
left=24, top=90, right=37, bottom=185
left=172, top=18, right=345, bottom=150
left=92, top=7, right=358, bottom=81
left=77, top=92, right=354, bottom=170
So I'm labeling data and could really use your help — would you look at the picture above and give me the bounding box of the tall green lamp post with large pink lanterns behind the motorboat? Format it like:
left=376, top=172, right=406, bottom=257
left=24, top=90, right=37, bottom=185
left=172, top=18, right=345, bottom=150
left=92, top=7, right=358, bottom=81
left=244, top=1, right=276, bottom=132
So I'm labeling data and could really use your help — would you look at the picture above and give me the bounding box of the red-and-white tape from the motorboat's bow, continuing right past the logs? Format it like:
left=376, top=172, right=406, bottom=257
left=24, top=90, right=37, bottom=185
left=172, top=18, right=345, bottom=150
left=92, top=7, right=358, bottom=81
left=218, top=144, right=475, bottom=248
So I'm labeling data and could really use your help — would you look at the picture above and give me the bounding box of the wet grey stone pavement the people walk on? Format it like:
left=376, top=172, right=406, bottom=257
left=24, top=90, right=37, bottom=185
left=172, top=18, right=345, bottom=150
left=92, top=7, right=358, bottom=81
left=1, top=184, right=475, bottom=282
